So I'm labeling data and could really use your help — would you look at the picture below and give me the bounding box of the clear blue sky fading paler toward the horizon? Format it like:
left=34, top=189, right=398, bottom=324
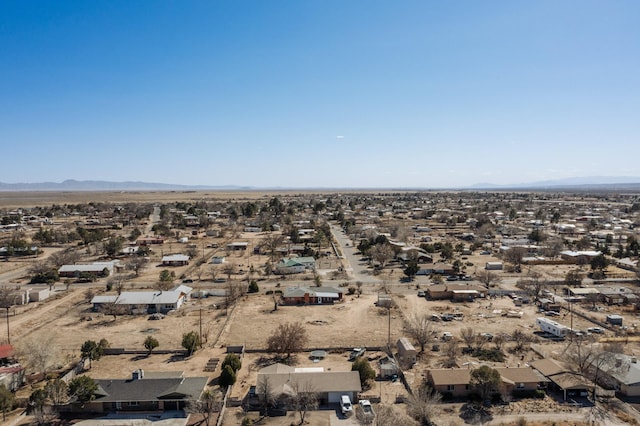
left=0, top=0, right=640, bottom=188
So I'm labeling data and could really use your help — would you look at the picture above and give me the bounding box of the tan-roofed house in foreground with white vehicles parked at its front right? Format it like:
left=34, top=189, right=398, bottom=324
left=256, top=364, right=362, bottom=404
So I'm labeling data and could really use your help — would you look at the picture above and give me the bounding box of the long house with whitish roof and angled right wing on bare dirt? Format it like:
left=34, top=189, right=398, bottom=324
left=91, top=285, right=193, bottom=314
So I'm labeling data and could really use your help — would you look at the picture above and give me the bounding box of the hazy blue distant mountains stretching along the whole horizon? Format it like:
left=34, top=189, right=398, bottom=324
left=0, top=176, right=640, bottom=191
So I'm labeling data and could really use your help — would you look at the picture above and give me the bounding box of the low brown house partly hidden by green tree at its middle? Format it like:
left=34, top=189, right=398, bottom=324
left=427, top=367, right=544, bottom=397
